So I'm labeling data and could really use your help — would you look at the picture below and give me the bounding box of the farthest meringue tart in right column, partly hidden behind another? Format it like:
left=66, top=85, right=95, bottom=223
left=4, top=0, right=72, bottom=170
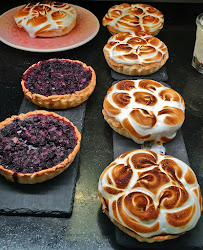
left=102, top=3, right=164, bottom=36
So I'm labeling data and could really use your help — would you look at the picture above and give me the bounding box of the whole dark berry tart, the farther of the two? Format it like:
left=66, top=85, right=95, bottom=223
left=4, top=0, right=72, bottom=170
left=21, top=59, right=96, bottom=109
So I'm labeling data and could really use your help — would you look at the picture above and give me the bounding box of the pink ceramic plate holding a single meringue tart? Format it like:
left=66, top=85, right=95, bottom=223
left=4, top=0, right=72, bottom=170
left=0, top=5, right=99, bottom=52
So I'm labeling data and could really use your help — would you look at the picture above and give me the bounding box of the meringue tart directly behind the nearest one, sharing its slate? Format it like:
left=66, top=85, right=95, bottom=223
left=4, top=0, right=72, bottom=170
left=102, top=79, right=185, bottom=145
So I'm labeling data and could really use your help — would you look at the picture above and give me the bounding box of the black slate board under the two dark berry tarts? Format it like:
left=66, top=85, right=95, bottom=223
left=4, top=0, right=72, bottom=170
left=0, top=98, right=86, bottom=217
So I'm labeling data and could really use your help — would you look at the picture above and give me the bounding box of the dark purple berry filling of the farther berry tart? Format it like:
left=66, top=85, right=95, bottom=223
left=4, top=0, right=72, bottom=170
left=23, top=59, right=92, bottom=96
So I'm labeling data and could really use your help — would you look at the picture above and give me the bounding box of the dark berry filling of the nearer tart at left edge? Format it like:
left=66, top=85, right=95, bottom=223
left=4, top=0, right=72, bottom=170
left=0, top=114, right=77, bottom=173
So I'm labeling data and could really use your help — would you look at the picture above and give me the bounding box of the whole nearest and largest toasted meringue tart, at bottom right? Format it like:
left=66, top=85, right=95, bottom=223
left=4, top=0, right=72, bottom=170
left=98, top=149, right=202, bottom=243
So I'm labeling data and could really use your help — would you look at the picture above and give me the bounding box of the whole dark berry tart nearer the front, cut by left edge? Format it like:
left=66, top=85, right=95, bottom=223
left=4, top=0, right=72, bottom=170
left=0, top=110, right=81, bottom=184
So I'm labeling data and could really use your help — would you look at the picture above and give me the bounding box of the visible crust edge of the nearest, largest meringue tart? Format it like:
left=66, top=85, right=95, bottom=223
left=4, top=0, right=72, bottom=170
left=98, top=191, right=185, bottom=243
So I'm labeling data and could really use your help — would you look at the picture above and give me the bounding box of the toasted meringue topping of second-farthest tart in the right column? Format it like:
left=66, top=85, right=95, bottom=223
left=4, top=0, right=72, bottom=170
left=104, top=32, right=168, bottom=65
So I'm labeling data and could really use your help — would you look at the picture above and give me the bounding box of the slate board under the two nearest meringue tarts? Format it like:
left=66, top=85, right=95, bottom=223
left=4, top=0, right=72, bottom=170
left=113, top=82, right=203, bottom=250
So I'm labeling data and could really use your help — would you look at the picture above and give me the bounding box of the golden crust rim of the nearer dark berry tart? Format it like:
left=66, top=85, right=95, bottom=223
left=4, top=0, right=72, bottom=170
left=0, top=110, right=81, bottom=184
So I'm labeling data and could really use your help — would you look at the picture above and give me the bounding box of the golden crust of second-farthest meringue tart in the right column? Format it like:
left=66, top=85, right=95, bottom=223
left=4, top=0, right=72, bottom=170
left=104, top=51, right=169, bottom=76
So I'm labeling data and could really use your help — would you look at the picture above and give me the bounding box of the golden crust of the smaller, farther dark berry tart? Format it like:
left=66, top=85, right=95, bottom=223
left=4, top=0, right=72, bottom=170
left=21, top=59, right=96, bottom=109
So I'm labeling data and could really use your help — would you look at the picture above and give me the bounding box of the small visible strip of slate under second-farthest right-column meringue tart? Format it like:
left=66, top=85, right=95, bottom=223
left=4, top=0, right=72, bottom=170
left=111, top=65, right=168, bottom=81
